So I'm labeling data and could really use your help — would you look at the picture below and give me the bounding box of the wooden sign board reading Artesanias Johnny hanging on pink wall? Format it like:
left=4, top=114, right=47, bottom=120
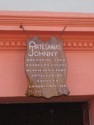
left=25, top=37, right=69, bottom=98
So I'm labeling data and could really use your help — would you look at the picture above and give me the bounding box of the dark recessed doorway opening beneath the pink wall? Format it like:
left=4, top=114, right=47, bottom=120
left=0, top=103, right=88, bottom=125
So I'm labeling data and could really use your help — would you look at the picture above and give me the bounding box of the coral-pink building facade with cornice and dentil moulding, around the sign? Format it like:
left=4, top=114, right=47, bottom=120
left=0, top=11, right=94, bottom=125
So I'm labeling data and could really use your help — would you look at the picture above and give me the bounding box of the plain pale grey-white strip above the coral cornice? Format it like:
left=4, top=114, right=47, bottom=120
left=0, top=0, right=94, bottom=13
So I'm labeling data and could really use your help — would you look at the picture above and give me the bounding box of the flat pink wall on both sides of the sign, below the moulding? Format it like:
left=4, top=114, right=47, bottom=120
left=0, top=51, right=94, bottom=97
